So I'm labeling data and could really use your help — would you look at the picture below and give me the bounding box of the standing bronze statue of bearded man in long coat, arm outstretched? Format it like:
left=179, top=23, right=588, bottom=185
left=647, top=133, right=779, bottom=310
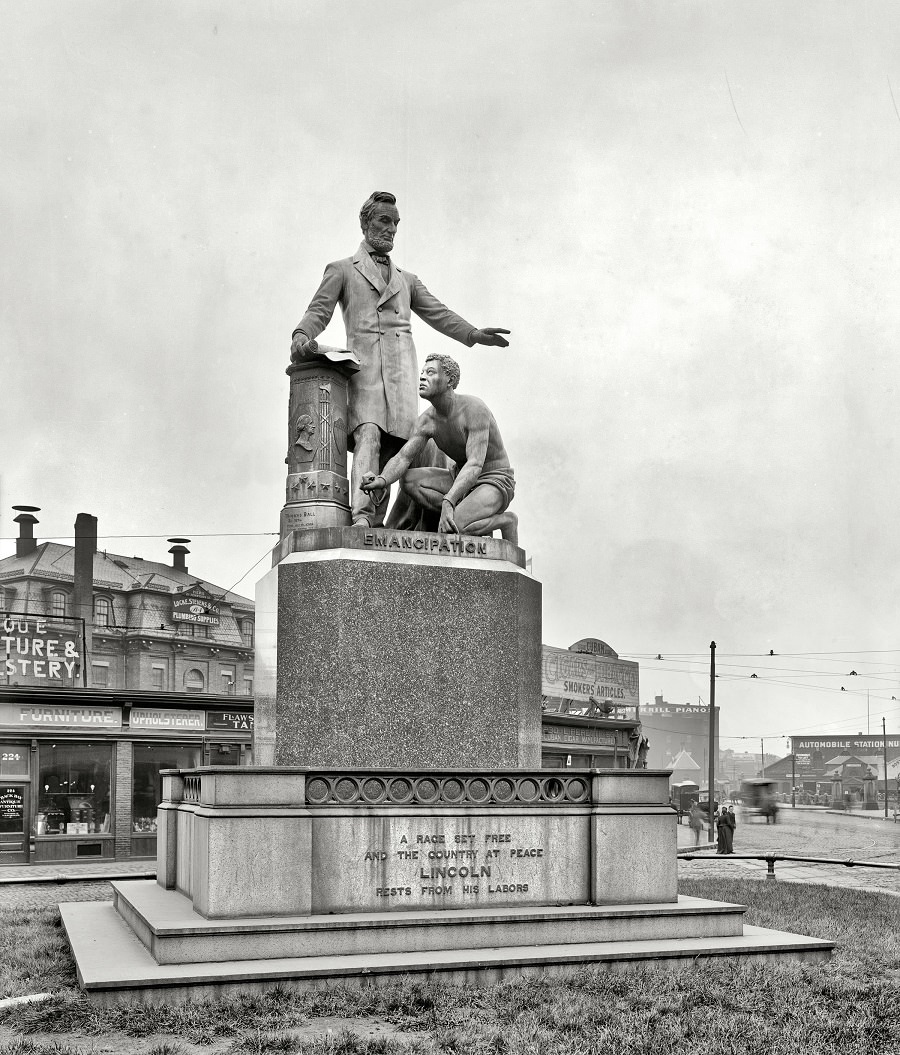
left=291, top=191, right=510, bottom=526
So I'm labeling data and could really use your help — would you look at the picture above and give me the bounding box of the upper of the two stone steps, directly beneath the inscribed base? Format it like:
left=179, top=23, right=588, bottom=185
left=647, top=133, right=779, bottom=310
left=112, top=881, right=744, bottom=963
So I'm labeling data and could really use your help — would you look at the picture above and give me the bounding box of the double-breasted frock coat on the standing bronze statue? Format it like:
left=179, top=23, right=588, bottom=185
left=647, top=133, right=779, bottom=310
left=294, top=243, right=475, bottom=449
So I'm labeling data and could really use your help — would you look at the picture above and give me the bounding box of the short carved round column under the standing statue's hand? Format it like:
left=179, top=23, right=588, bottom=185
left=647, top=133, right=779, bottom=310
left=281, top=342, right=359, bottom=538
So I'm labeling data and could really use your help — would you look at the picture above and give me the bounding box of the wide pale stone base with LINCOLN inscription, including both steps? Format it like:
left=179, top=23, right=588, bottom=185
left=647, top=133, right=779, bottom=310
left=60, top=767, right=831, bottom=1001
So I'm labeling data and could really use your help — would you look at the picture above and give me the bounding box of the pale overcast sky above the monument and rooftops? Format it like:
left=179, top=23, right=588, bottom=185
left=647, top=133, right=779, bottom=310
left=0, top=0, right=900, bottom=753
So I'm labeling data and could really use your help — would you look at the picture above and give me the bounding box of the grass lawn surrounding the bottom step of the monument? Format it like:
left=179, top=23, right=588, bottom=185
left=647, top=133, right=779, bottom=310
left=0, top=879, right=900, bottom=1055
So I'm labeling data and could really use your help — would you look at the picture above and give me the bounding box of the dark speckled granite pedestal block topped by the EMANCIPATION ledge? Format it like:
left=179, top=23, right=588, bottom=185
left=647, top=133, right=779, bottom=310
left=254, top=528, right=541, bottom=768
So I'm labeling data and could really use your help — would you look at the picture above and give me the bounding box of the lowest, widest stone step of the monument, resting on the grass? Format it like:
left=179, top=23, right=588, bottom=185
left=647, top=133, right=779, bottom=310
left=59, top=901, right=832, bottom=1003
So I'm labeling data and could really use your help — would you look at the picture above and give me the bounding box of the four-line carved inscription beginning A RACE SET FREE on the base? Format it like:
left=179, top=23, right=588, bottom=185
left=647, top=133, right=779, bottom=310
left=363, top=831, right=544, bottom=898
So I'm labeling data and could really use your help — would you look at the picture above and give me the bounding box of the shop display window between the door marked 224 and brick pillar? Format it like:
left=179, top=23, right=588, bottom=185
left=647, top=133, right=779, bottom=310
left=35, top=744, right=113, bottom=836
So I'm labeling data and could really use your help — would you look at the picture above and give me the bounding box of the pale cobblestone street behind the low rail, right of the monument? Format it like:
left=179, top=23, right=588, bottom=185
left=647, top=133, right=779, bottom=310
left=678, top=807, right=900, bottom=894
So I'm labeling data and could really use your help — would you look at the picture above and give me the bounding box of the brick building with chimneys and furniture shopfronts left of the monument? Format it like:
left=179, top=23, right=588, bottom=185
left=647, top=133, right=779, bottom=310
left=0, top=506, right=254, bottom=863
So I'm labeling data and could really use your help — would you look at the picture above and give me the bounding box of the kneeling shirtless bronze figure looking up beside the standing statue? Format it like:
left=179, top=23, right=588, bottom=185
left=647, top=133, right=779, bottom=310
left=361, top=354, right=518, bottom=543
